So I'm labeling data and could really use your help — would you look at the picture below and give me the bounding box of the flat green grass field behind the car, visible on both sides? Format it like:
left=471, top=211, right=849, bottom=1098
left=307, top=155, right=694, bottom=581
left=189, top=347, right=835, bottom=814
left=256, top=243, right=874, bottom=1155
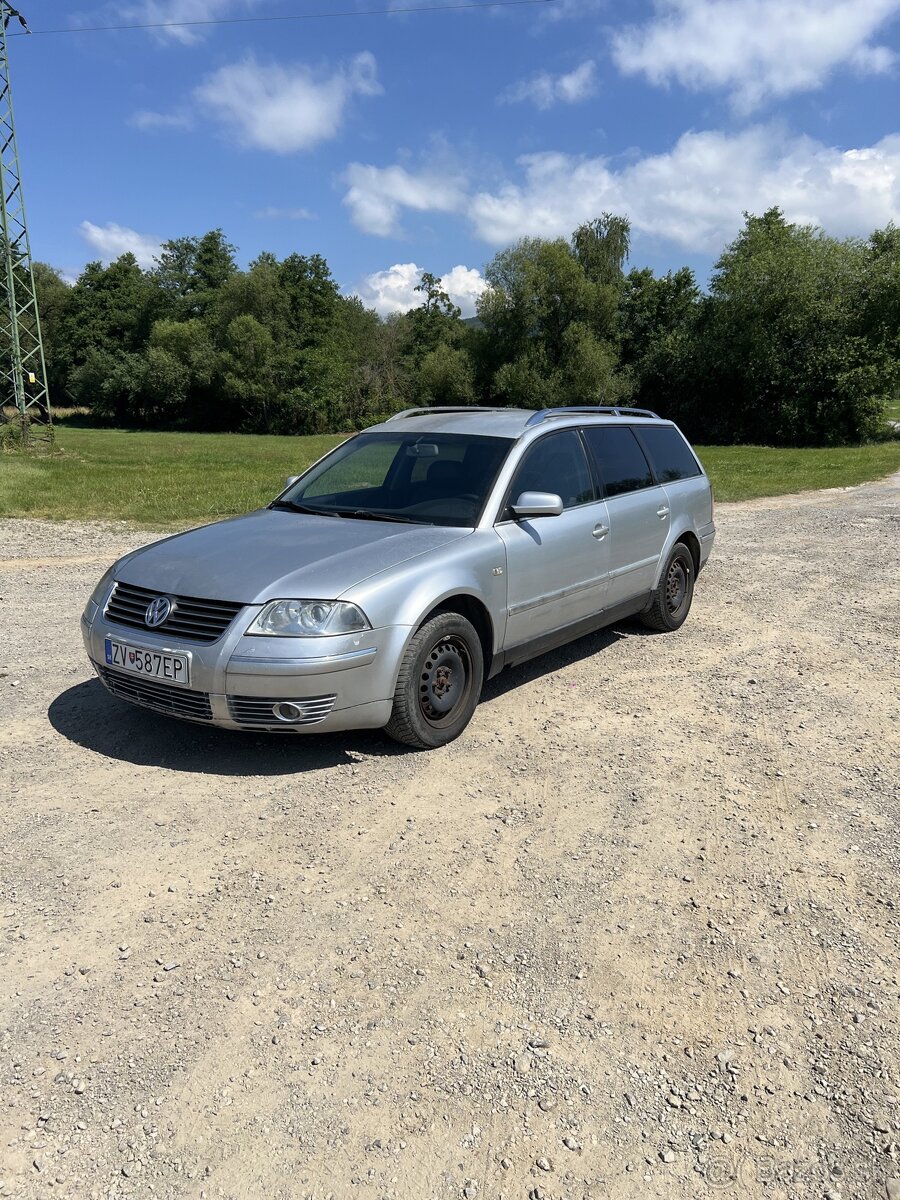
left=0, top=426, right=900, bottom=528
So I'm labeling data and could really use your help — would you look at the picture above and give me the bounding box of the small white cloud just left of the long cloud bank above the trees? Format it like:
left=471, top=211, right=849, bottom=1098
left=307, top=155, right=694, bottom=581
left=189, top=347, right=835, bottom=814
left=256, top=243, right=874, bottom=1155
left=343, top=162, right=466, bottom=238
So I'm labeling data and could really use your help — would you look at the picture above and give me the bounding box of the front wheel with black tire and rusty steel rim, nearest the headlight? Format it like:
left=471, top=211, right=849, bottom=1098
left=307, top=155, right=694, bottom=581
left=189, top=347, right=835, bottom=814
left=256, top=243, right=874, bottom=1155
left=384, top=612, right=485, bottom=750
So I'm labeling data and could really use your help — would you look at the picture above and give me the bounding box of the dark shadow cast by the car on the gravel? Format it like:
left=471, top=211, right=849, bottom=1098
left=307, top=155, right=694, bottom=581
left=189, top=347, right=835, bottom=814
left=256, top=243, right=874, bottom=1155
left=47, top=622, right=653, bottom=776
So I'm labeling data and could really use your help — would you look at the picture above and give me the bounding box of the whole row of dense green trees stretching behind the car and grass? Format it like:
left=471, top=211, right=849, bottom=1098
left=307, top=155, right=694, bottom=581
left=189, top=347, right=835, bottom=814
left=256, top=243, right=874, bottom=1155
left=35, top=209, right=900, bottom=445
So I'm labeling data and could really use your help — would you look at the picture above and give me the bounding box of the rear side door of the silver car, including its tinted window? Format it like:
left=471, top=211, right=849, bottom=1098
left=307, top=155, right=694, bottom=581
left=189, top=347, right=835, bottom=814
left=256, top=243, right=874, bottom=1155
left=583, top=425, right=670, bottom=607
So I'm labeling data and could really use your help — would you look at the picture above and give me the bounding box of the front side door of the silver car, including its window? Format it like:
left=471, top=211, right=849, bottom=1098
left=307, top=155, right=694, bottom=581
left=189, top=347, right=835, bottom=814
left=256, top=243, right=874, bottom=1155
left=496, top=430, right=610, bottom=649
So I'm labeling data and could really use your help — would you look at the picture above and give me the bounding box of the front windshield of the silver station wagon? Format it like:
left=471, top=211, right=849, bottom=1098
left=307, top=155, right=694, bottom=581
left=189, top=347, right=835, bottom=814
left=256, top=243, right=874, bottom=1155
left=275, top=433, right=512, bottom=526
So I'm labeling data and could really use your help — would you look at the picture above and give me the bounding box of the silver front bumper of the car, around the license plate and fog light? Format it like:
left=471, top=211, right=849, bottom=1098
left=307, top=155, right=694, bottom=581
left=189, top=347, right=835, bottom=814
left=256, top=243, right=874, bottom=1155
left=82, top=601, right=413, bottom=733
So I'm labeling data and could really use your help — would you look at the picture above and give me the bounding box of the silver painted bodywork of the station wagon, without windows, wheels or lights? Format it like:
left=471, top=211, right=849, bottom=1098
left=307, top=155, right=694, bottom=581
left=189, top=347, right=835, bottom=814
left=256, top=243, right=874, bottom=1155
left=82, top=409, right=715, bottom=732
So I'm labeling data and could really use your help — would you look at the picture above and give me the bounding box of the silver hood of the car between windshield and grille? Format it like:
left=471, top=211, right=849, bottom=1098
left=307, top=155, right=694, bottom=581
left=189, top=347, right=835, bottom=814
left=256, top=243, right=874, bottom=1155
left=116, top=509, right=472, bottom=604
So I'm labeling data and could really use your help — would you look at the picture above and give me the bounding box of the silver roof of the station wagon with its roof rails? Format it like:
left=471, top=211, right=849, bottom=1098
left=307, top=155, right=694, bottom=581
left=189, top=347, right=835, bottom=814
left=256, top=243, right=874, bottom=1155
left=365, top=407, right=672, bottom=438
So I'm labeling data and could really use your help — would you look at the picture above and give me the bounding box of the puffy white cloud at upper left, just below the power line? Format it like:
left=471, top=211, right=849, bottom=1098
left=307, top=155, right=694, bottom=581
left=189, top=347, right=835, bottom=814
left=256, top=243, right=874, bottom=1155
left=194, top=50, right=382, bottom=154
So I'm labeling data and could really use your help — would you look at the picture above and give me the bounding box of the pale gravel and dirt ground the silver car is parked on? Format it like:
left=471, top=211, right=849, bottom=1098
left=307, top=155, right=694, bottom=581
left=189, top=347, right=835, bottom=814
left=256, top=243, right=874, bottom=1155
left=0, top=475, right=900, bottom=1200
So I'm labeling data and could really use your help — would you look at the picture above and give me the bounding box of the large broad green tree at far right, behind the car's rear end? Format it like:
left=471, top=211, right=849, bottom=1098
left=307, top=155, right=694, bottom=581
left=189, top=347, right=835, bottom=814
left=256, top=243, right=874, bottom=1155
left=692, top=209, right=896, bottom=445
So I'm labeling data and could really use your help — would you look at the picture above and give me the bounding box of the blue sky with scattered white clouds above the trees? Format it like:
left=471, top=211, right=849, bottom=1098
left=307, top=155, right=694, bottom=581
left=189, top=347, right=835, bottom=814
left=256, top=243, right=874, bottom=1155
left=10, top=0, right=900, bottom=313
